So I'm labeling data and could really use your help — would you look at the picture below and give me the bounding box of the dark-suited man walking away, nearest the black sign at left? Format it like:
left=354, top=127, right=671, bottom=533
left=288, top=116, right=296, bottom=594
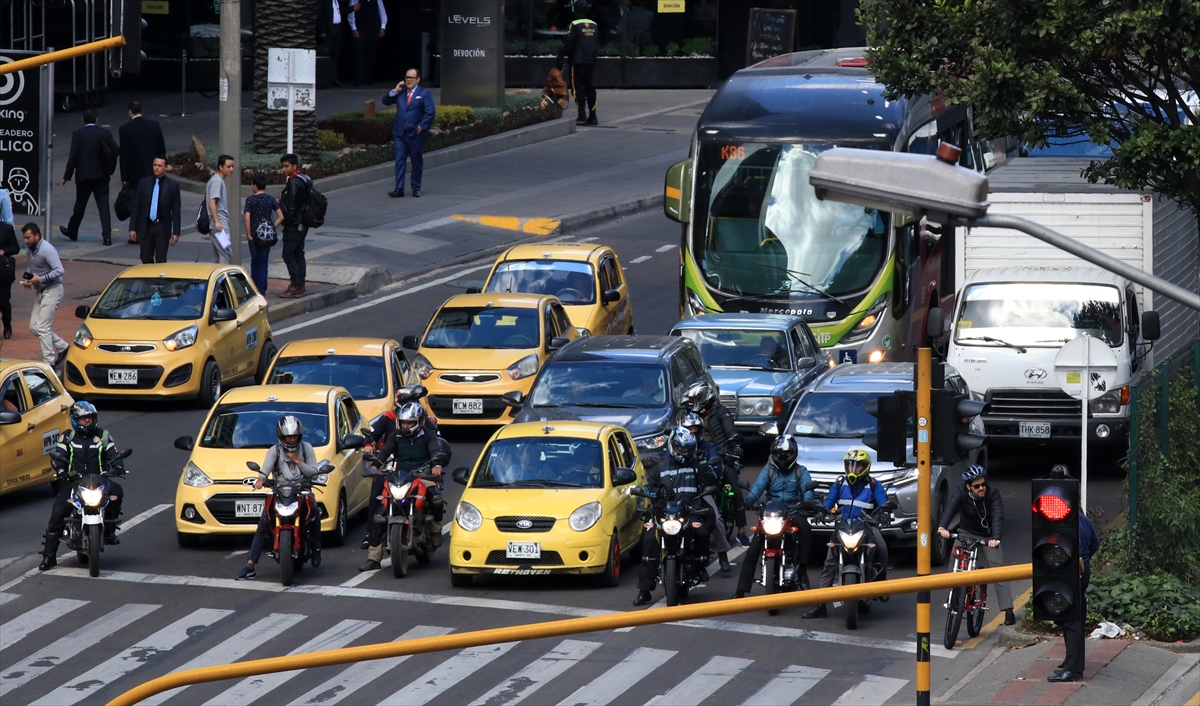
left=59, top=108, right=121, bottom=245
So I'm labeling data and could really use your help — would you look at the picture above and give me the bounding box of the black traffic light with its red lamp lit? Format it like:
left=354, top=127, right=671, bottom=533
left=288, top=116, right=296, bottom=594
left=1032, top=471, right=1079, bottom=622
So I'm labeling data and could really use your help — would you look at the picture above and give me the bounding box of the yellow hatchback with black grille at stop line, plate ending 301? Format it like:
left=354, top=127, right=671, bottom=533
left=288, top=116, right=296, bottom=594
left=450, top=421, right=646, bottom=587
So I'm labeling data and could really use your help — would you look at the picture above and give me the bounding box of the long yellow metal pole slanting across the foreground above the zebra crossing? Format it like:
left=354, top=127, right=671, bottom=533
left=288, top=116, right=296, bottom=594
left=108, top=564, right=1033, bottom=706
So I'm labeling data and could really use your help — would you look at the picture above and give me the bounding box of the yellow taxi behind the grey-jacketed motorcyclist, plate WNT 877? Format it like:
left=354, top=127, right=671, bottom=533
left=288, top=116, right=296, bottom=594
left=175, top=385, right=371, bottom=548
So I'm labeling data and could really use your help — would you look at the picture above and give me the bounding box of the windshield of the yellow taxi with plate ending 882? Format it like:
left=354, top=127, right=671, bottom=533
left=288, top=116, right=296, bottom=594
left=424, top=306, right=541, bottom=348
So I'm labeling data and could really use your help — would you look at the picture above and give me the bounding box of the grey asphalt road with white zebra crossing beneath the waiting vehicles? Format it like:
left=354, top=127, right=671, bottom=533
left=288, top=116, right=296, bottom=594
left=0, top=206, right=1121, bottom=705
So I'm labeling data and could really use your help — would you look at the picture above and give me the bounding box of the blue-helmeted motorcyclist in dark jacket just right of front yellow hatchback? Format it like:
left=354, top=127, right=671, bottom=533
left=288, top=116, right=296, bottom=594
left=634, top=426, right=716, bottom=605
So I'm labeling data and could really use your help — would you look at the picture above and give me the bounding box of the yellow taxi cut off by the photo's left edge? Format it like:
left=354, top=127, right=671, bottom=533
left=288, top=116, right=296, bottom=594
left=0, top=359, right=74, bottom=495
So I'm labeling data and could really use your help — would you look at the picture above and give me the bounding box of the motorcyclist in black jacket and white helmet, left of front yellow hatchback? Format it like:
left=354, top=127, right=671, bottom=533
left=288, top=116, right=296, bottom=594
left=359, top=402, right=445, bottom=572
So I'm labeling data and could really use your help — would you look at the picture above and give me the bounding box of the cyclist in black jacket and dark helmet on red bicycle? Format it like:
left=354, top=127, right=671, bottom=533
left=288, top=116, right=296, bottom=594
left=937, top=465, right=1016, bottom=626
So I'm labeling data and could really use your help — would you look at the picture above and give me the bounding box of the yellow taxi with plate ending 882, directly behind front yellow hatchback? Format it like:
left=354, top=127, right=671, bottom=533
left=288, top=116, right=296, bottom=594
left=403, top=293, right=581, bottom=426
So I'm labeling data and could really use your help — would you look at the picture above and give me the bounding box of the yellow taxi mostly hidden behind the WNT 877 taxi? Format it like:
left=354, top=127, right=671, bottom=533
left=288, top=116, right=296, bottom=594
left=264, top=337, right=420, bottom=421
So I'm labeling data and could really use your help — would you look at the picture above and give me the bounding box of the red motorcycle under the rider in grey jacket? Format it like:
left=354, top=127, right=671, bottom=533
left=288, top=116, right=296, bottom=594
left=246, top=461, right=334, bottom=586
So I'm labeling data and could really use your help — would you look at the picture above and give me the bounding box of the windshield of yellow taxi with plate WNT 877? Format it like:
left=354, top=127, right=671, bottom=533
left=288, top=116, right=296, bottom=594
left=200, top=402, right=329, bottom=449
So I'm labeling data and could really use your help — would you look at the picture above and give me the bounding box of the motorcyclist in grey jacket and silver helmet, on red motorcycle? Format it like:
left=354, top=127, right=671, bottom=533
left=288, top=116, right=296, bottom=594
left=236, top=414, right=320, bottom=581
